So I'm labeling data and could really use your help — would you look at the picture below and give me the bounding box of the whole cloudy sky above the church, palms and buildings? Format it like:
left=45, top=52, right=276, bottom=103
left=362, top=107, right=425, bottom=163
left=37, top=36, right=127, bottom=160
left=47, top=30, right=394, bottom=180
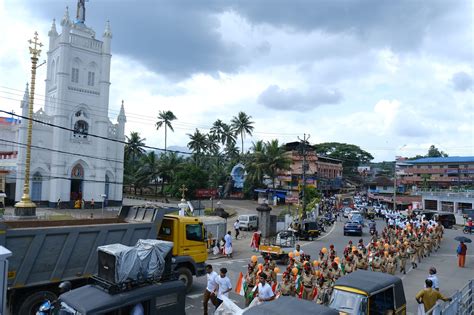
left=0, top=0, right=474, bottom=161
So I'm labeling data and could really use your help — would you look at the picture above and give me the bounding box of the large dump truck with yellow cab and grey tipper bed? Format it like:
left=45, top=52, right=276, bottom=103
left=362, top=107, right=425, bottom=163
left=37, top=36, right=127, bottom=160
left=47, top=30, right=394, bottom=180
left=0, top=205, right=207, bottom=314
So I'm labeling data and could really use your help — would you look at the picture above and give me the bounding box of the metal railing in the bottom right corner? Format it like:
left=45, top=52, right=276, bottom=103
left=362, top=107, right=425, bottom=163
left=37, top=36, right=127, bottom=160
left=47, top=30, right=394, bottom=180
left=426, top=279, right=474, bottom=315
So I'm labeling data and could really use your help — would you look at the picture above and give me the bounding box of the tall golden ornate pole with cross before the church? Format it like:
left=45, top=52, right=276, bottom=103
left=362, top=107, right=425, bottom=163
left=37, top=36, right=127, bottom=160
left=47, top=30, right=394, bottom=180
left=15, top=32, right=43, bottom=217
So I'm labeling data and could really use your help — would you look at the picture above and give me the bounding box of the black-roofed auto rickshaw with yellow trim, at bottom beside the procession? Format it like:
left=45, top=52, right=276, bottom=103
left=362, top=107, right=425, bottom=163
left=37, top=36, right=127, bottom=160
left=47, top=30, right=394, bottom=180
left=329, top=270, right=406, bottom=315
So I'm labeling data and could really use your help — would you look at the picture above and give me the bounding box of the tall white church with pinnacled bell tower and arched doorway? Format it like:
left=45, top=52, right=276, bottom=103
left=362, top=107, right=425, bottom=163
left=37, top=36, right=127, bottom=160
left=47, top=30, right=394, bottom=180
left=15, top=0, right=126, bottom=207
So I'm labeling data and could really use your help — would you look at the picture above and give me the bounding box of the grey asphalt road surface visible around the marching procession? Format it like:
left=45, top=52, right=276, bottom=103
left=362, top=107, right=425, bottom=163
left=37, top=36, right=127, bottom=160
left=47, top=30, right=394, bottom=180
left=186, top=216, right=474, bottom=314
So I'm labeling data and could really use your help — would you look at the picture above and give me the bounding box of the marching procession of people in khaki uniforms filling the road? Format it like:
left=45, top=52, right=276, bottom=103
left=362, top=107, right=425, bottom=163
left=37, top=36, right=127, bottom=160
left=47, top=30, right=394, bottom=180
left=244, top=213, right=444, bottom=305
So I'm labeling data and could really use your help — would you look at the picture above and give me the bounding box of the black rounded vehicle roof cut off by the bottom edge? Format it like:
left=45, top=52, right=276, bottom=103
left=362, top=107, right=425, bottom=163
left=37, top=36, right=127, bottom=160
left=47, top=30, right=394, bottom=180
left=244, top=296, right=339, bottom=315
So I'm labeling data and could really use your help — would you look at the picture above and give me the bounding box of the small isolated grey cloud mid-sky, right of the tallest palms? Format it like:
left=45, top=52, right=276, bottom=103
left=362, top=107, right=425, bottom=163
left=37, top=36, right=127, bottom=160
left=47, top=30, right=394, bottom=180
left=258, top=85, right=342, bottom=111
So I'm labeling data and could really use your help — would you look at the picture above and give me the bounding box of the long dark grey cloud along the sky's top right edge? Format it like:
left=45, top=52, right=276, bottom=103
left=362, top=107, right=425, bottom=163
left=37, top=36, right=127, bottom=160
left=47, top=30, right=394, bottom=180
left=234, top=0, right=464, bottom=51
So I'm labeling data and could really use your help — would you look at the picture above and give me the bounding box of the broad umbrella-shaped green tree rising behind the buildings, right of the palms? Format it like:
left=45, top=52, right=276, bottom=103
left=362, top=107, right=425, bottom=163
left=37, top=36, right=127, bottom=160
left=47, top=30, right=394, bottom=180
left=315, top=142, right=374, bottom=177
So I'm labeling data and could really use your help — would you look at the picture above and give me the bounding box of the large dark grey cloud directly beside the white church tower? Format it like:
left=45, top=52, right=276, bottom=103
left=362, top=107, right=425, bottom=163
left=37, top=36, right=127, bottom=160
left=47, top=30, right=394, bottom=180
left=25, top=0, right=248, bottom=80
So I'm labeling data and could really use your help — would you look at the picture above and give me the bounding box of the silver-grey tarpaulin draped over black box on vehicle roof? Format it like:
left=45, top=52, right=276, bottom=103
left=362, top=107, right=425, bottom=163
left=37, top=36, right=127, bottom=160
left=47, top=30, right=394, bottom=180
left=97, top=239, right=173, bottom=283
